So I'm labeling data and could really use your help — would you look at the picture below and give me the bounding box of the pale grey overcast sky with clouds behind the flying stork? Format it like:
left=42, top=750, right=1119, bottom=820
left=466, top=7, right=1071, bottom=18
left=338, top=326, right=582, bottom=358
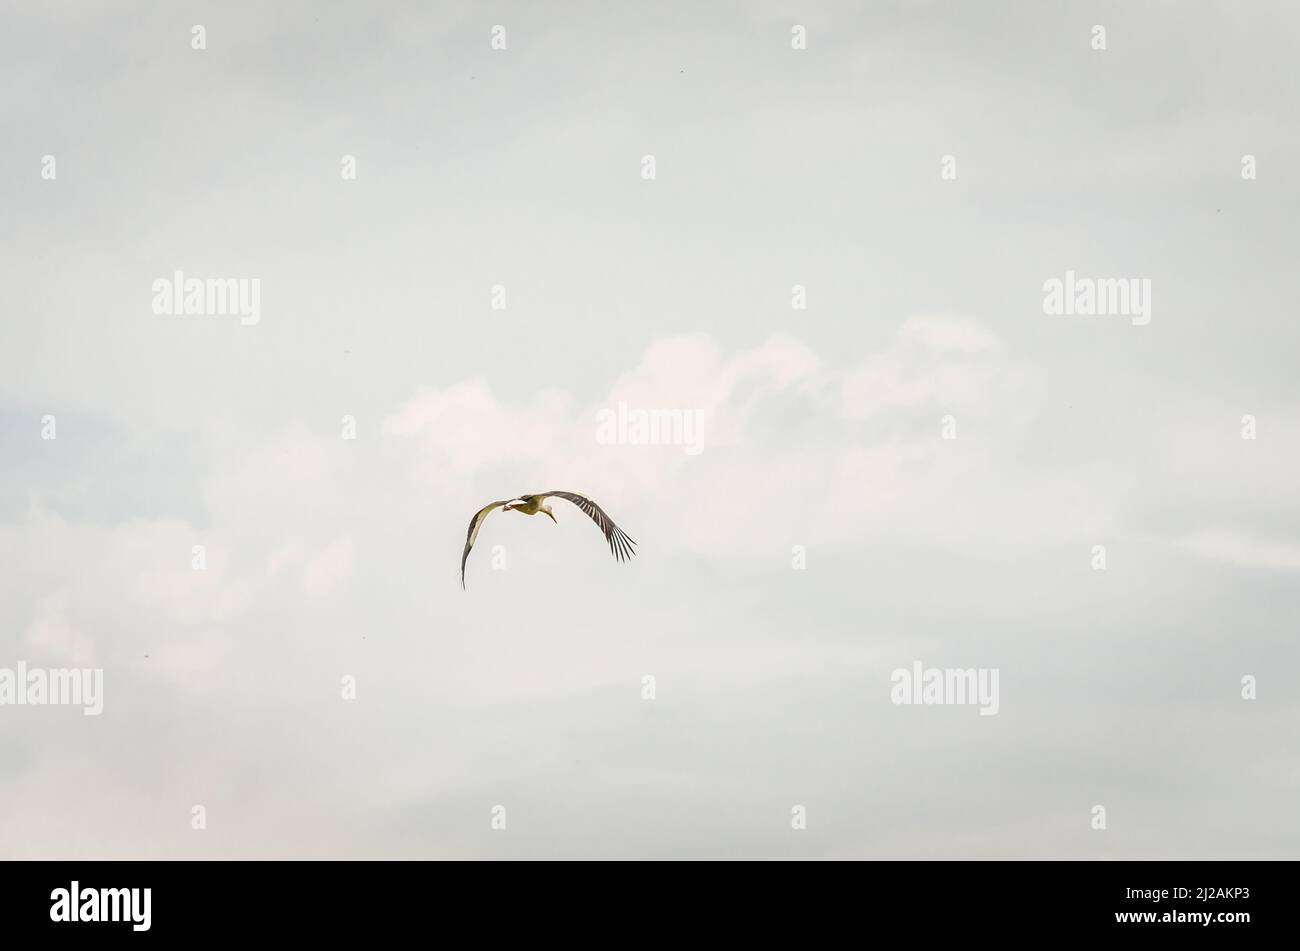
left=0, top=0, right=1300, bottom=859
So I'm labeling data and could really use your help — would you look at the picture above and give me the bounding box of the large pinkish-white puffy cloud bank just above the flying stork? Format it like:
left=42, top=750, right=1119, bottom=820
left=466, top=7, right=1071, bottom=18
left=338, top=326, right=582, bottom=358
left=384, top=314, right=1089, bottom=553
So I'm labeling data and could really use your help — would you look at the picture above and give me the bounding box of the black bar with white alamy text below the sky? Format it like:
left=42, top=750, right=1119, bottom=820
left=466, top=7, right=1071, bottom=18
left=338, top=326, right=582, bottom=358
left=0, top=861, right=1279, bottom=943
